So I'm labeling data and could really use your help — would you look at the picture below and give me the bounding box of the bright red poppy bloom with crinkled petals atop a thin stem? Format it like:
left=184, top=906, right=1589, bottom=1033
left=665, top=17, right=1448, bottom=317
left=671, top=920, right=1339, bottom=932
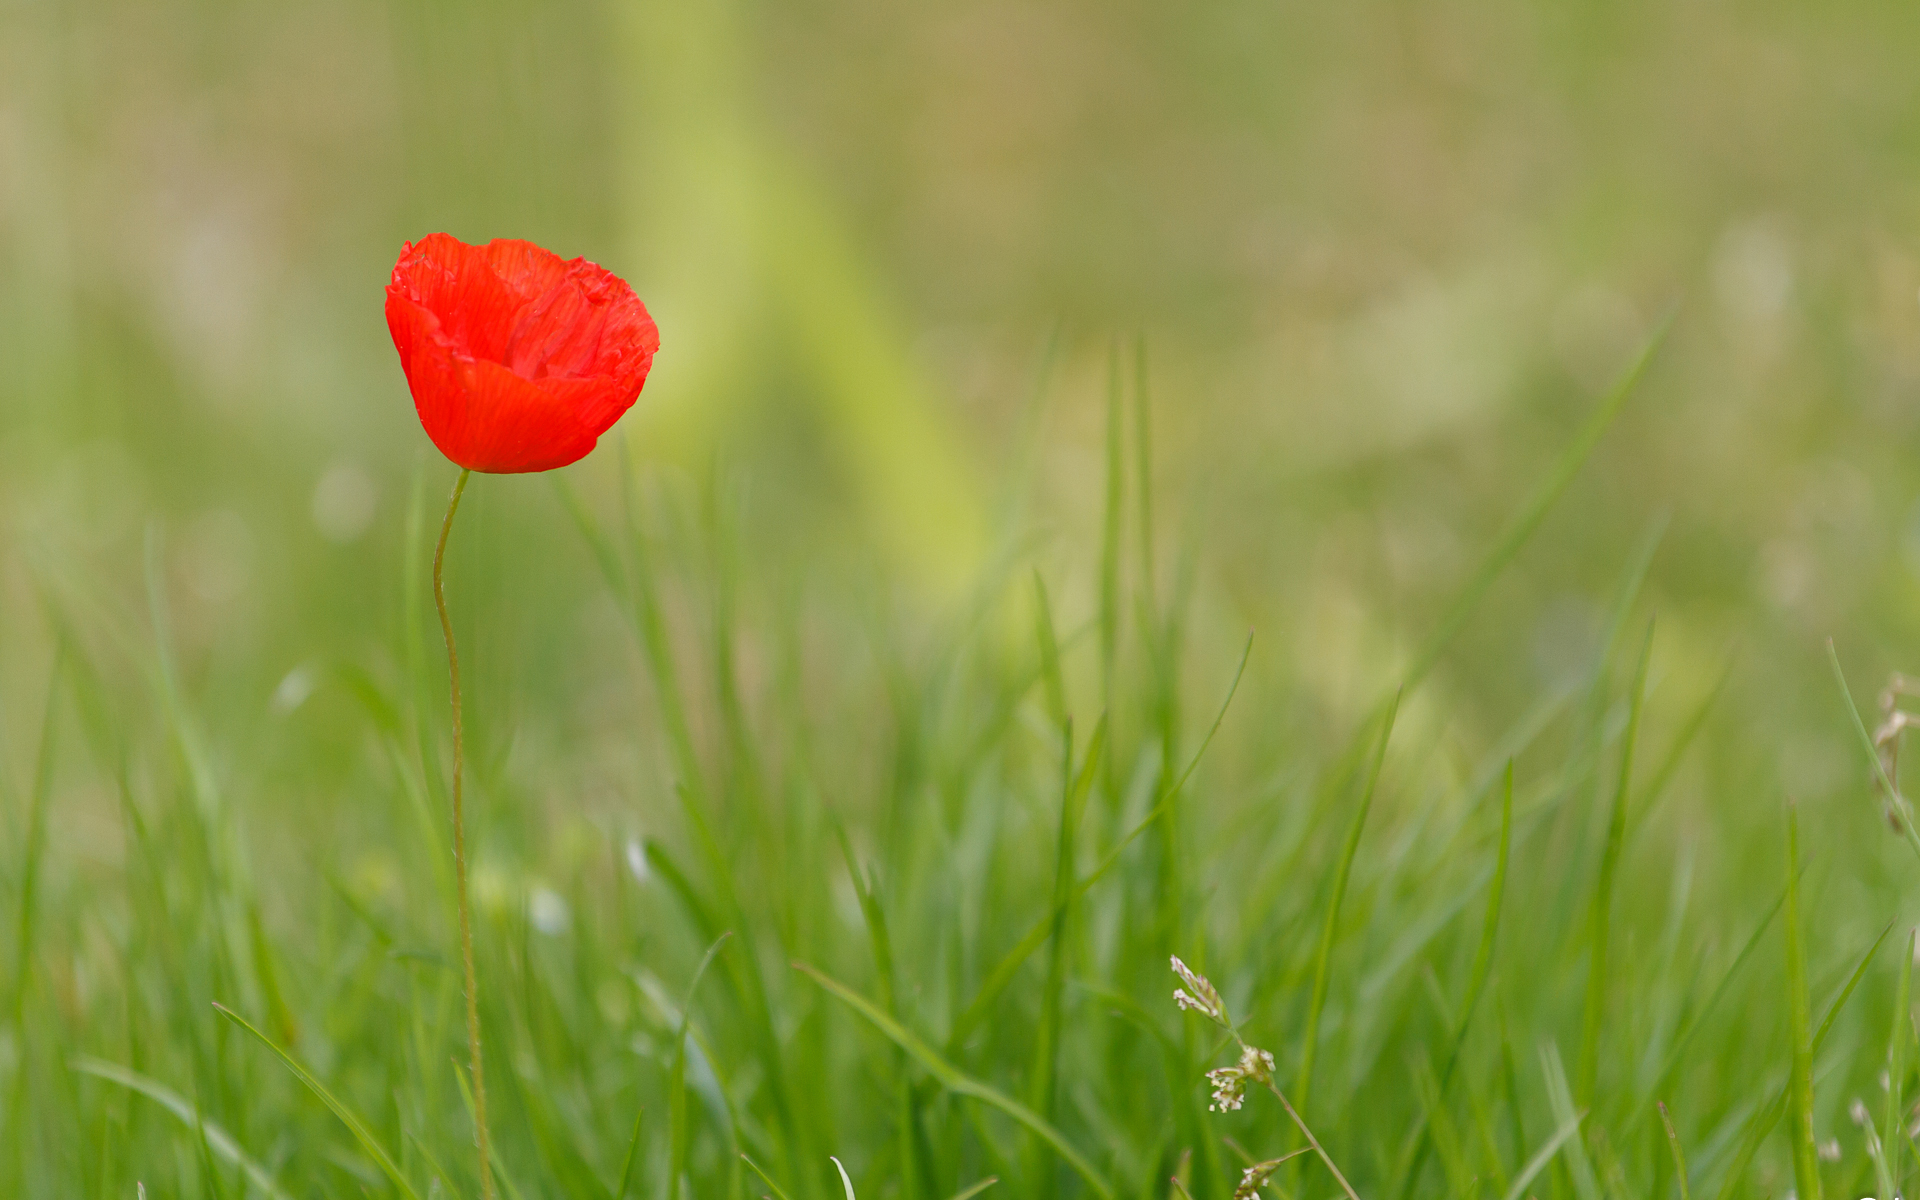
left=386, top=234, right=660, bottom=474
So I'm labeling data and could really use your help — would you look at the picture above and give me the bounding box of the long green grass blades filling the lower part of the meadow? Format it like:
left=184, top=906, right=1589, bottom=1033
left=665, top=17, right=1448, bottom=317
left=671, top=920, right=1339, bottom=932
left=11, top=320, right=1912, bottom=1200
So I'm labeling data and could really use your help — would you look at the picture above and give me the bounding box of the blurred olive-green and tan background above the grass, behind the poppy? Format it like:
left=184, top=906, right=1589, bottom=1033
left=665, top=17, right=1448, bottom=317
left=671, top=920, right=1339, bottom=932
left=11, top=0, right=1920, bottom=741
